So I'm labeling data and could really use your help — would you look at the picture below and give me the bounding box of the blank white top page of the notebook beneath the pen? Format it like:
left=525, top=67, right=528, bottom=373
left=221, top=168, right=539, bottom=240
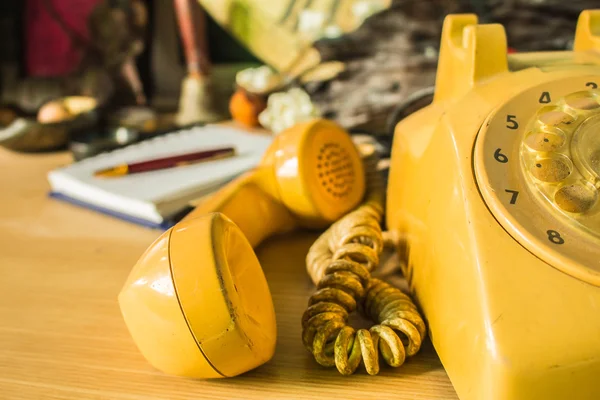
left=49, top=125, right=273, bottom=212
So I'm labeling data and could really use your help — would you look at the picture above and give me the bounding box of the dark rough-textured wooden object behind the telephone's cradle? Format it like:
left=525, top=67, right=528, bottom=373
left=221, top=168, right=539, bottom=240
left=305, top=0, right=597, bottom=134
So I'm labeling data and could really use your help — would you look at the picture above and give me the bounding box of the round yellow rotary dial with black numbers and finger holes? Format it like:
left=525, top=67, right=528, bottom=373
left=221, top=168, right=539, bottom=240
left=473, top=76, right=600, bottom=286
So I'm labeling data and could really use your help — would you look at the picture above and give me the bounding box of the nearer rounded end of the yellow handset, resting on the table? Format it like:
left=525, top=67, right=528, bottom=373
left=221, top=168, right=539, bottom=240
left=119, top=213, right=276, bottom=378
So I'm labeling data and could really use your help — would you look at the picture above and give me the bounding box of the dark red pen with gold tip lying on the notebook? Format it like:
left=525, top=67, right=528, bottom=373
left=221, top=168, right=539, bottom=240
left=94, top=147, right=235, bottom=178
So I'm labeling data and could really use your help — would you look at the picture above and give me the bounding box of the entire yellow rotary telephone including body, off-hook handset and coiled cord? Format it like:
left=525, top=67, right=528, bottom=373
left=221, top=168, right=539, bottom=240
left=119, top=7, right=600, bottom=400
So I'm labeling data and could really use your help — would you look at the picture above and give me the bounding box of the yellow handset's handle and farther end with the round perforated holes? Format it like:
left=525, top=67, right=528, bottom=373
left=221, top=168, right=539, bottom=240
left=185, top=119, right=365, bottom=246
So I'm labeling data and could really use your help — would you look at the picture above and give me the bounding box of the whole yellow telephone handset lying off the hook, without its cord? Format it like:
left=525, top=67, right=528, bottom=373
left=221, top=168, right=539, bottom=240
left=119, top=120, right=365, bottom=378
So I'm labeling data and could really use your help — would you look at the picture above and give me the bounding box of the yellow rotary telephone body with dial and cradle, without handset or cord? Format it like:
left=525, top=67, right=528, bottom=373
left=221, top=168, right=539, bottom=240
left=386, top=10, right=600, bottom=400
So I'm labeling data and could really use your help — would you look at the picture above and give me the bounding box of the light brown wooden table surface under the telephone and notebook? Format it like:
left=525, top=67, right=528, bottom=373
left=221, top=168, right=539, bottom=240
left=0, top=149, right=456, bottom=400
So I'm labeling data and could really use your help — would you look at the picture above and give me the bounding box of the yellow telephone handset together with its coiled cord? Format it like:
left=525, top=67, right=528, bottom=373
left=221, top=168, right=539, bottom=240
left=119, top=115, right=426, bottom=378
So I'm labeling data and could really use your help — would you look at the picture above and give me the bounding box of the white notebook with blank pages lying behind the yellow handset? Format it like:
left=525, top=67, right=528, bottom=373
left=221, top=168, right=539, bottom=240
left=48, top=125, right=272, bottom=229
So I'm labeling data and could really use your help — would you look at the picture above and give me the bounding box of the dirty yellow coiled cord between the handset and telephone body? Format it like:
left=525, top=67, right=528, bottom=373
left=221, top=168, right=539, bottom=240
left=302, top=146, right=426, bottom=375
